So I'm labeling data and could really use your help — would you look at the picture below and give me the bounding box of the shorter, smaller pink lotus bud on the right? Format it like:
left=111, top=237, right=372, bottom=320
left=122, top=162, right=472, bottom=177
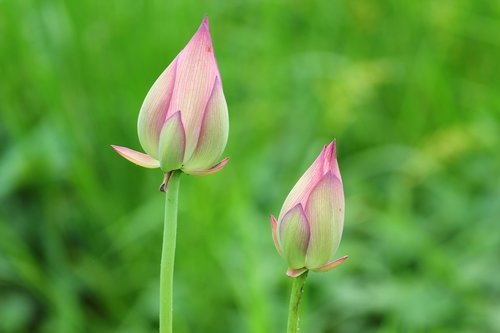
left=271, top=141, right=347, bottom=277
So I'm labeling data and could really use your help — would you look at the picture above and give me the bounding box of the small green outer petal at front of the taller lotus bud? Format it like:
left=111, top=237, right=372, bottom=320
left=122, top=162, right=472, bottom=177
left=159, top=111, right=186, bottom=173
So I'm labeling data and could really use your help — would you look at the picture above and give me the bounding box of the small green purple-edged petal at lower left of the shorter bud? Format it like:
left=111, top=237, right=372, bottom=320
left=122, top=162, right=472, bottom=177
left=278, top=204, right=309, bottom=269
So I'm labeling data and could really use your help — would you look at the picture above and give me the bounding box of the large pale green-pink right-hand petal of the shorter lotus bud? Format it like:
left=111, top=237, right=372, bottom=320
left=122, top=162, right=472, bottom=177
left=306, top=172, right=344, bottom=269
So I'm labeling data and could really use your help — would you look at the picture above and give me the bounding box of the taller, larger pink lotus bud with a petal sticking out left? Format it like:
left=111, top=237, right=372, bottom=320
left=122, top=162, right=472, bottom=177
left=113, top=17, right=229, bottom=174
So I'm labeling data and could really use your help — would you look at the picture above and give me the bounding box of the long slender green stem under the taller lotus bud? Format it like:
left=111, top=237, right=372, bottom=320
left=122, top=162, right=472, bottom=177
left=160, top=171, right=182, bottom=333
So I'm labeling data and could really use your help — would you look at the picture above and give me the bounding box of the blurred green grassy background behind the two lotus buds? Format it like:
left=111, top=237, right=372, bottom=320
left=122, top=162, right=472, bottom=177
left=0, top=0, right=500, bottom=333
